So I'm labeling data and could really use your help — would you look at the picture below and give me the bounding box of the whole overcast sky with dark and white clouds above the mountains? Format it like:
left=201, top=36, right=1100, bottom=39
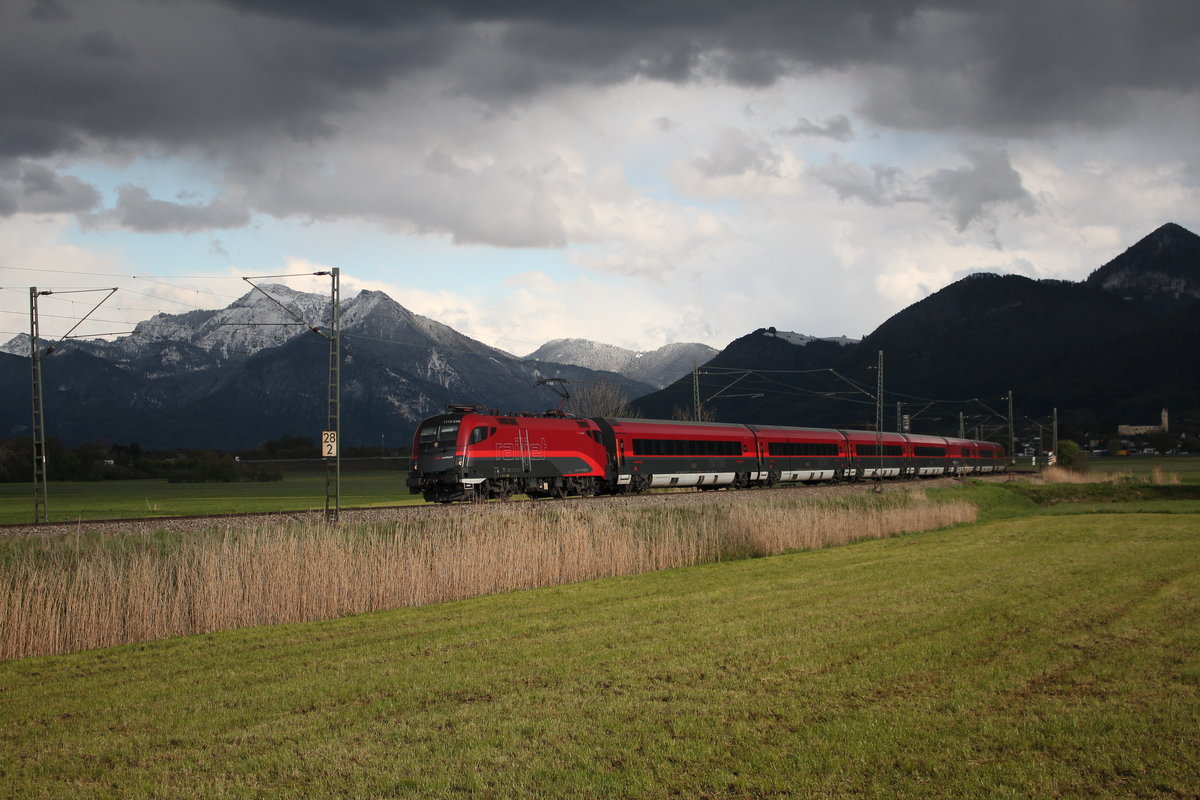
left=0, top=0, right=1200, bottom=354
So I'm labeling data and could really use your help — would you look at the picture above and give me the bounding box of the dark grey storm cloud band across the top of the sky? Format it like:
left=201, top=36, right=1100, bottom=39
left=0, top=0, right=1200, bottom=163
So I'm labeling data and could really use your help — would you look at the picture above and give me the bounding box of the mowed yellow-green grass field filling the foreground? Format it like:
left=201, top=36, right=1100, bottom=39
left=0, top=510, right=1200, bottom=798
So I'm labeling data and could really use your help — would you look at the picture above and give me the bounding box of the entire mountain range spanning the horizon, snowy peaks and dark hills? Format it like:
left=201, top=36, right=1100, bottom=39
left=0, top=223, right=1200, bottom=449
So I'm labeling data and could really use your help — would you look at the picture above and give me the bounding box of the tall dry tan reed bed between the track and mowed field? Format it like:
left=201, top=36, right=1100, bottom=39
left=0, top=492, right=976, bottom=658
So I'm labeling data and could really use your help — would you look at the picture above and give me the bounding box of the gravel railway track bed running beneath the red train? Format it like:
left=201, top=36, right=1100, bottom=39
left=0, top=474, right=1012, bottom=536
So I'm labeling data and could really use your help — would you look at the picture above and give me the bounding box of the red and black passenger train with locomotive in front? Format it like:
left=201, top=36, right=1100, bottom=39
left=407, top=405, right=1006, bottom=503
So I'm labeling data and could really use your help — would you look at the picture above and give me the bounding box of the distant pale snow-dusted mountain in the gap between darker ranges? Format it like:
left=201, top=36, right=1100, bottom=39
left=524, top=339, right=716, bottom=389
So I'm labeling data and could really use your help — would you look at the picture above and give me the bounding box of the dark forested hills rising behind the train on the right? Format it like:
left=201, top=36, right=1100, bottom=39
left=638, top=223, right=1200, bottom=433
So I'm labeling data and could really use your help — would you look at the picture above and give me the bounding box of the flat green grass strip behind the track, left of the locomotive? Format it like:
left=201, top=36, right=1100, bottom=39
left=0, top=470, right=424, bottom=524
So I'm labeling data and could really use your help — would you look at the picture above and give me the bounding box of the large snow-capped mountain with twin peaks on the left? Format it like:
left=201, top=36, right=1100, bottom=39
left=0, top=285, right=653, bottom=450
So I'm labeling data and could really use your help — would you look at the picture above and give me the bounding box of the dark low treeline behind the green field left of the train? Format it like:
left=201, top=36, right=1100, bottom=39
left=0, top=437, right=407, bottom=483
